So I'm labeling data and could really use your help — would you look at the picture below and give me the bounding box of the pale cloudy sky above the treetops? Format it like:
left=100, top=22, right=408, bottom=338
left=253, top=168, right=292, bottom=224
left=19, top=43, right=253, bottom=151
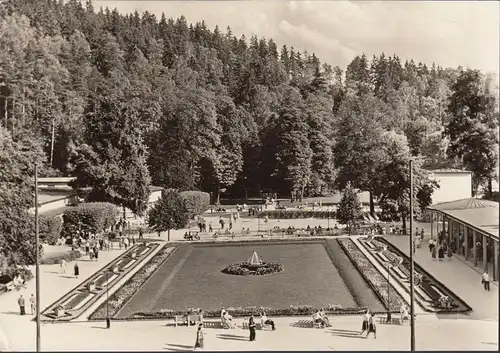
left=94, top=0, right=500, bottom=74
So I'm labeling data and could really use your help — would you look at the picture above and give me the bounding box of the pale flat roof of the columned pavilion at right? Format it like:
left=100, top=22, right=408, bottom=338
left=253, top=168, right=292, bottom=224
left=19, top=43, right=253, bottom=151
left=427, top=198, right=500, bottom=239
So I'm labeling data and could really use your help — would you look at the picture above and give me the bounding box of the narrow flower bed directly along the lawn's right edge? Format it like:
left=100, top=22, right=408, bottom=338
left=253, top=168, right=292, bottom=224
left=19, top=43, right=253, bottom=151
left=338, top=239, right=405, bottom=312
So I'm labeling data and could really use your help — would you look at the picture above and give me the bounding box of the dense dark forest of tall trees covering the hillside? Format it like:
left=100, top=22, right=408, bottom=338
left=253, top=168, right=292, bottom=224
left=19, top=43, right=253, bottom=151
left=0, top=0, right=498, bottom=228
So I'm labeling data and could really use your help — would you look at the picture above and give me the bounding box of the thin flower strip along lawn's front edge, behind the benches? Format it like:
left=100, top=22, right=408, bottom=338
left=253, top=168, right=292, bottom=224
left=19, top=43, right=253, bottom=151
left=127, top=304, right=374, bottom=320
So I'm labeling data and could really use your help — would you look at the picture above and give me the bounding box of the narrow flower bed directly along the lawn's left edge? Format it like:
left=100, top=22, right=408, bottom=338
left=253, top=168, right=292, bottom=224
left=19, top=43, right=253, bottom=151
left=89, top=247, right=178, bottom=320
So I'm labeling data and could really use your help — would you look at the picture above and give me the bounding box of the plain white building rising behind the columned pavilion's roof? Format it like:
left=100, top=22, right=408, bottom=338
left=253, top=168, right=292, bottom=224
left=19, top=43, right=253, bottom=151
left=430, top=168, right=472, bottom=205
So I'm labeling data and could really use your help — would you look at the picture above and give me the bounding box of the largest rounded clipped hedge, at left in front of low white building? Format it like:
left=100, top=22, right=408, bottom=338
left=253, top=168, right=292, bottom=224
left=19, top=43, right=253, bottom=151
left=63, top=202, right=118, bottom=237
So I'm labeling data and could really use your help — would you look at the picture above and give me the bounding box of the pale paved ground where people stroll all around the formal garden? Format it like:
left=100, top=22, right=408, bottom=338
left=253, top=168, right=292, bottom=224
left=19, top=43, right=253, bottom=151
left=0, top=214, right=498, bottom=351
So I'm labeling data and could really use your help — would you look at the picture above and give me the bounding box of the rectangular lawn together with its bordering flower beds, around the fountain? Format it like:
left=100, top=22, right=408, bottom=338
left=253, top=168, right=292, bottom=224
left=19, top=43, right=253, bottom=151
left=81, top=239, right=410, bottom=320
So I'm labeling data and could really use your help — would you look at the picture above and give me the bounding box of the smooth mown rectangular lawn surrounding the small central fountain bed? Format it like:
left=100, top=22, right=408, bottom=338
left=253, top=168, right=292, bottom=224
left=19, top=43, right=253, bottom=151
left=115, top=240, right=381, bottom=319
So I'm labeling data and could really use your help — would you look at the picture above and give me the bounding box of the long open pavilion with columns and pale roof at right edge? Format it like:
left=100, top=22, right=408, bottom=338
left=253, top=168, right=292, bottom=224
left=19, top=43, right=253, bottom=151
left=427, top=198, right=500, bottom=281
